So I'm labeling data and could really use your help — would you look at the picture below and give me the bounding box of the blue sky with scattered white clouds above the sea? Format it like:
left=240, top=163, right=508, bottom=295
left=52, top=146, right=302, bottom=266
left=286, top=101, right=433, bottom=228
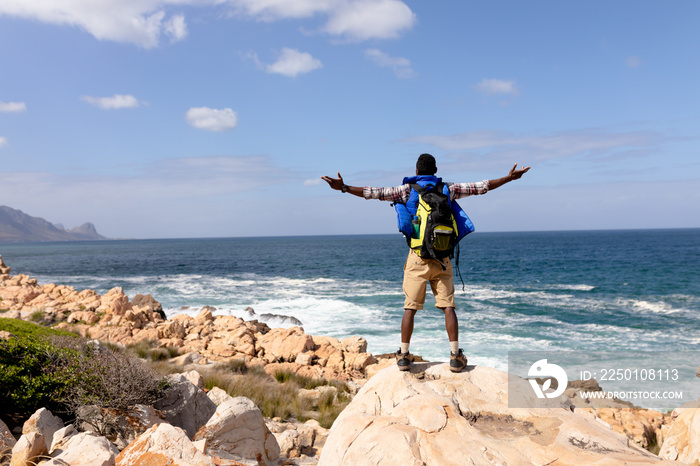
left=0, top=0, right=700, bottom=238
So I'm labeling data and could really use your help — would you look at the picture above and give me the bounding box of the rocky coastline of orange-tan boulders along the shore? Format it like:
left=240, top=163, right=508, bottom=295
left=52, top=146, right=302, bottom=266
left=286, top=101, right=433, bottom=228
left=0, top=257, right=700, bottom=465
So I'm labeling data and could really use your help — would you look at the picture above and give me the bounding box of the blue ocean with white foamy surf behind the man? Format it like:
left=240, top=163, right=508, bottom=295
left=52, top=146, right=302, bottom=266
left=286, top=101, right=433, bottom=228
left=0, top=229, right=700, bottom=408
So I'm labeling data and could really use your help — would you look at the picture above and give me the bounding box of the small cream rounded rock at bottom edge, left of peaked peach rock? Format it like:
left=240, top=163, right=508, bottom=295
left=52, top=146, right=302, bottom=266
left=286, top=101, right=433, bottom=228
left=41, top=432, right=119, bottom=466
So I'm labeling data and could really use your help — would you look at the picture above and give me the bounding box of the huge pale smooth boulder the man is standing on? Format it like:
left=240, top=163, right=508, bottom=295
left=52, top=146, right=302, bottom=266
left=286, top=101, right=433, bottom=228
left=319, top=363, right=670, bottom=466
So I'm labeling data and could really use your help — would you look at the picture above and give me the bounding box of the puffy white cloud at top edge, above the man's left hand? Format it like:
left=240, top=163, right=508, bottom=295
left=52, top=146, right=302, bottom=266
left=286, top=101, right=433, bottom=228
left=324, top=0, right=416, bottom=40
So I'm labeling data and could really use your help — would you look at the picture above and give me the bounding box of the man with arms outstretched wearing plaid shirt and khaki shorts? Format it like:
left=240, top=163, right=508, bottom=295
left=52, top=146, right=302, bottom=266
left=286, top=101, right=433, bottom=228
left=321, top=154, right=530, bottom=372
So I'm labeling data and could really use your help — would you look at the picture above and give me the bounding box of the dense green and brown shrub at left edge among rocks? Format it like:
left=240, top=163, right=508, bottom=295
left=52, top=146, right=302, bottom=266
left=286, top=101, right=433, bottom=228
left=0, top=326, right=167, bottom=428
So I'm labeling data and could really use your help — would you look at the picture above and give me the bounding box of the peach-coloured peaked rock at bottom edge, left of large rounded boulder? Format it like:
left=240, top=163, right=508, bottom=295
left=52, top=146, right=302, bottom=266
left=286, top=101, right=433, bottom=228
left=115, top=423, right=214, bottom=466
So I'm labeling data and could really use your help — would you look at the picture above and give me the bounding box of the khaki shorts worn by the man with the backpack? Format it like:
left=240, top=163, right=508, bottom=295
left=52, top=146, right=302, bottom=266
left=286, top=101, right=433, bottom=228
left=403, top=249, right=455, bottom=311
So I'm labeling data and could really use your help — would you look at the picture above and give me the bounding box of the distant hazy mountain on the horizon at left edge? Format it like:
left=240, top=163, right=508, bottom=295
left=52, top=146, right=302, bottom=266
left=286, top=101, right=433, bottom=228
left=0, top=206, right=107, bottom=242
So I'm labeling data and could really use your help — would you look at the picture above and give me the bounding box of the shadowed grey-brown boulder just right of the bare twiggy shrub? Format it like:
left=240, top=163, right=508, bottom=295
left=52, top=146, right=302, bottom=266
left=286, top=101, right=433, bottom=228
left=154, top=374, right=216, bottom=438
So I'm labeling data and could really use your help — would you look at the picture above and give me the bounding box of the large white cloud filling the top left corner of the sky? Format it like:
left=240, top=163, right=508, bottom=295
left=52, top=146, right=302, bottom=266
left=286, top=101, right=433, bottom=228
left=0, top=0, right=191, bottom=48
